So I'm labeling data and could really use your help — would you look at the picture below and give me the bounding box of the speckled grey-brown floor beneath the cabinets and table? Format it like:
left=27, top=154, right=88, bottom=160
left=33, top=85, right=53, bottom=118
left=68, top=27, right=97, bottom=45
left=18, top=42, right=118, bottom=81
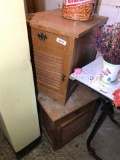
left=0, top=105, right=120, bottom=160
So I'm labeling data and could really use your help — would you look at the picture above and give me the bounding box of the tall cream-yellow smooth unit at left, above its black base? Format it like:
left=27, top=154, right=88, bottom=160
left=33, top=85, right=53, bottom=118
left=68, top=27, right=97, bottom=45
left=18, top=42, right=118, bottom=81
left=0, top=0, right=40, bottom=152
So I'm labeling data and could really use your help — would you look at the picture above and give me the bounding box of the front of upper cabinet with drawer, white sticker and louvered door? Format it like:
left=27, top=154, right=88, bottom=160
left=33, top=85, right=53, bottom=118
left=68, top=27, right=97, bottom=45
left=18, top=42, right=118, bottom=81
left=32, top=28, right=70, bottom=103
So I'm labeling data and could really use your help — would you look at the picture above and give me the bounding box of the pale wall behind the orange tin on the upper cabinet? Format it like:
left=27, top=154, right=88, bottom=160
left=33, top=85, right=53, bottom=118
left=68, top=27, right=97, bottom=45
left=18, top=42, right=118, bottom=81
left=39, top=0, right=120, bottom=24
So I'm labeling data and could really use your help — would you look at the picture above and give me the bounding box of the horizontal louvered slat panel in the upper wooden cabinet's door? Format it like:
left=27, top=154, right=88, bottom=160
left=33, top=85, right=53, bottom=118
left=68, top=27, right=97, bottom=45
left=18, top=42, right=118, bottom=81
left=34, top=52, right=63, bottom=90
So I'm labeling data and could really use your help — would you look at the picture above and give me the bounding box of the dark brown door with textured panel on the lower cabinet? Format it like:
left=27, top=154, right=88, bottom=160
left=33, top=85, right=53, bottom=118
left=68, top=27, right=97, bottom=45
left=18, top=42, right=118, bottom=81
left=56, top=103, right=93, bottom=148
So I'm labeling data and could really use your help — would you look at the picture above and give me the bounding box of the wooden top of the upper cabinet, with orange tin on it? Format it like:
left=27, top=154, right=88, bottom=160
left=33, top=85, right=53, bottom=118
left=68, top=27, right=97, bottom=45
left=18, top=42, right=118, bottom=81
left=27, top=9, right=108, bottom=37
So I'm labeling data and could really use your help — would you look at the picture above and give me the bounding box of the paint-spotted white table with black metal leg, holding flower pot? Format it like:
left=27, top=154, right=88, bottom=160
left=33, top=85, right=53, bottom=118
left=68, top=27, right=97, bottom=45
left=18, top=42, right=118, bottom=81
left=70, top=57, right=120, bottom=160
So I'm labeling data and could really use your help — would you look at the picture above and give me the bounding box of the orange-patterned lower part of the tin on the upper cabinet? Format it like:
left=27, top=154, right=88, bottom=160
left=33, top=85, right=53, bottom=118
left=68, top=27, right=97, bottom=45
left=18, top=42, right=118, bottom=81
left=62, top=3, right=94, bottom=21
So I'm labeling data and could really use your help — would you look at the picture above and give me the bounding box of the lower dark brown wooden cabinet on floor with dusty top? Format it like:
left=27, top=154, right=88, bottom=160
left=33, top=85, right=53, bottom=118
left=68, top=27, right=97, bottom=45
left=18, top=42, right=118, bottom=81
left=38, top=86, right=98, bottom=150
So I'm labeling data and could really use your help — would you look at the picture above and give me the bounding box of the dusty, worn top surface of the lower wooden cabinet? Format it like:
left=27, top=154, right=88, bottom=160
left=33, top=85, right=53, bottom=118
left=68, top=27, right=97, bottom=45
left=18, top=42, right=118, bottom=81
left=38, top=85, right=99, bottom=122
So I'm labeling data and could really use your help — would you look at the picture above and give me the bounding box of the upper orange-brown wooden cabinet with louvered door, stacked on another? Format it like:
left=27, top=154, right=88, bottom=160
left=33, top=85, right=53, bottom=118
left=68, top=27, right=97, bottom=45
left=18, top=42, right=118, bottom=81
left=27, top=10, right=108, bottom=104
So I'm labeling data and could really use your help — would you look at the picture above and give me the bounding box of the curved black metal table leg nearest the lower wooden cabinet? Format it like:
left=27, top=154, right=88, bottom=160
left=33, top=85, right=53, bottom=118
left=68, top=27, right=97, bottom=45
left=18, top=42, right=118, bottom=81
left=87, top=99, right=109, bottom=160
